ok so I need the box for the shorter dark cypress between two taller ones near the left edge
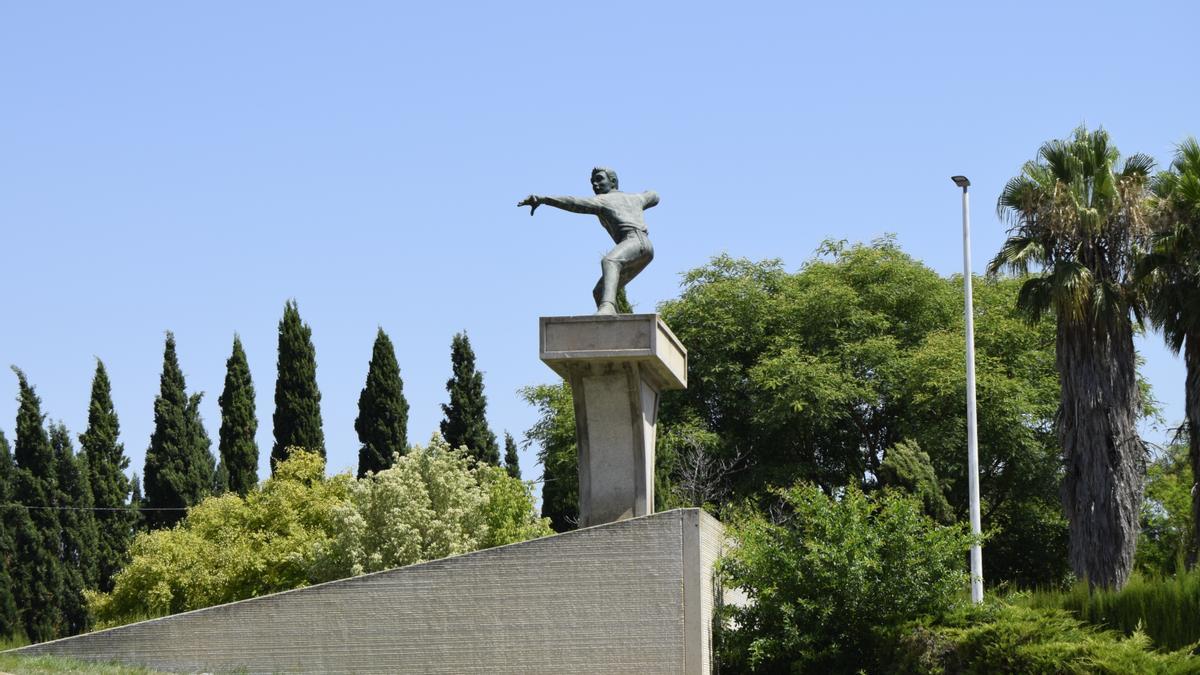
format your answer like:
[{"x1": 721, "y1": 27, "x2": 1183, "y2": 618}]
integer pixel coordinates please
[{"x1": 50, "y1": 422, "x2": 97, "y2": 635}]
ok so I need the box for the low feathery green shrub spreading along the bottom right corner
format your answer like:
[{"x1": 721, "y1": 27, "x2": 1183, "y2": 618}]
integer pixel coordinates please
[{"x1": 888, "y1": 602, "x2": 1200, "y2": 675}]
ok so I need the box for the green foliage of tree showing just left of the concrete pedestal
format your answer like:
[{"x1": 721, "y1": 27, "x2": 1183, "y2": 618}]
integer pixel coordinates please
[{"x1": 521, "y1": 381, "x2": 580, "y2": 532}]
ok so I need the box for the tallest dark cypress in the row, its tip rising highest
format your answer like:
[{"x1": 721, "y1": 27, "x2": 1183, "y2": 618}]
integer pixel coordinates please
[{"x1": 271, "y1": 300, "x2": 325, "y2": 472}]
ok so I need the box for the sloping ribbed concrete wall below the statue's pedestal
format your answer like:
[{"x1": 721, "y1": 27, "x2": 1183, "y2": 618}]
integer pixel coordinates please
[{"x1": 9, "y1": 509, "x2": 724, "y2": 674}]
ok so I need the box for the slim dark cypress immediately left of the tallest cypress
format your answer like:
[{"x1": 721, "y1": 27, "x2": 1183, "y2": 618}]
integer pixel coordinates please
[{"x1": 217, "y1": 335, "x2": 258, "y2": 496}]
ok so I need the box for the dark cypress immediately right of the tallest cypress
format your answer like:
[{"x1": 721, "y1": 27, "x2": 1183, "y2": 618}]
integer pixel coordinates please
[{"x1": 354, "y1": 328, "x2": 408, "y2": 478}]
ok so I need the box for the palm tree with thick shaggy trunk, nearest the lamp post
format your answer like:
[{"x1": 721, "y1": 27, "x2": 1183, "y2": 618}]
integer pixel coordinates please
[{"x1": 989, "y1": 127, "x2": 1154, "y2": 587}]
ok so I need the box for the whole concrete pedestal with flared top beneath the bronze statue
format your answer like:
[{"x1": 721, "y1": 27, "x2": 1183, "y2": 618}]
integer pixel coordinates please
[{"x1": 539, "y1": 313, "x2": 688, "y2": 527}]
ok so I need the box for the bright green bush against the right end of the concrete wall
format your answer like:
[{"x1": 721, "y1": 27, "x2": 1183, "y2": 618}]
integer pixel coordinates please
[{"x1": 720, "y1": 484, "x2": 971, "y2": 673}]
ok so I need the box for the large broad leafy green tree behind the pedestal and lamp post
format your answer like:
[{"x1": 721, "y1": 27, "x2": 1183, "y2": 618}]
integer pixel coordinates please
[{"x1": 648, "y1": 238, "x2": 1067, "y2": 585}]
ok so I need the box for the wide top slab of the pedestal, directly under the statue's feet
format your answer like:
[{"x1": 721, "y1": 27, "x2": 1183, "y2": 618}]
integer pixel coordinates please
[{"x1": 539, "y1": 313, "x2": 688, "y2": 389}]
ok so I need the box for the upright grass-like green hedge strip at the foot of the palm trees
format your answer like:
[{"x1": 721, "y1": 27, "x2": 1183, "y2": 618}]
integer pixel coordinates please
[{"x1": 1013, "y1": 569, "x2": 1200, "y2": 650}]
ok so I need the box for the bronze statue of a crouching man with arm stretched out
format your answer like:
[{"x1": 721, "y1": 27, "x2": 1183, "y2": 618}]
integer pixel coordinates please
[{"x1": 517, "y1": 167, "x2": 659, "y2": 315}]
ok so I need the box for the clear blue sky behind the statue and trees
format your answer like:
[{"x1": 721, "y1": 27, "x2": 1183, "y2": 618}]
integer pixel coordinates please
[{"x1": 0, "y1": 1, "x2": 1200, "y2": 494}]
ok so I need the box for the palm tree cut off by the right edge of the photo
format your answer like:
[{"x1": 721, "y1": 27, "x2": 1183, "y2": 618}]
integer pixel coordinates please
[{"x1": 1138, "y1": 138, "x2": 1200, "y2": 566}]
